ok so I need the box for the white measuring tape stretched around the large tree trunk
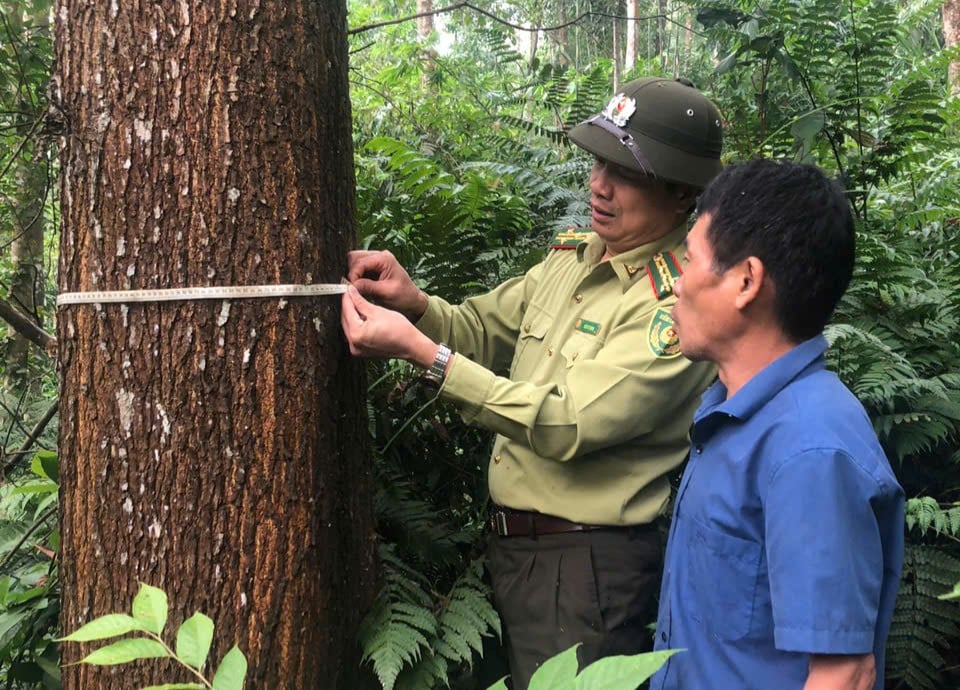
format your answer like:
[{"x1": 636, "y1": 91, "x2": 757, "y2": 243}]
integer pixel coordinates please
[{"x1": 57, "y1": 283, "x2": 348, "y2": 307}]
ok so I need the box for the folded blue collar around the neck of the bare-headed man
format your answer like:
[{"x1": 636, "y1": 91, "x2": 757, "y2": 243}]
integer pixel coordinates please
[{"x1": 693, "y1": 334, "x2": 827, "y2": 424}]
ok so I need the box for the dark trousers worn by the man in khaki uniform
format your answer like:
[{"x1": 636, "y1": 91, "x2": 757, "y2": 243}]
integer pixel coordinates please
[{"x1": 487, "y1": 526, "x2": 661, "y2": 690}]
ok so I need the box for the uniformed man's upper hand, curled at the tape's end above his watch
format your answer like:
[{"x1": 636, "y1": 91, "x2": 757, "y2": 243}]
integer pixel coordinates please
[{"x1": 347, "y1": 250, "x2": 427, "y2": 322}]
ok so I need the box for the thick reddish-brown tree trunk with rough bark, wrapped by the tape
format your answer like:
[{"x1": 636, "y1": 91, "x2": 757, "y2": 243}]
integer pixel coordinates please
[{"x1": 54, "y1": 0, "x2": 374, "y2": 690}]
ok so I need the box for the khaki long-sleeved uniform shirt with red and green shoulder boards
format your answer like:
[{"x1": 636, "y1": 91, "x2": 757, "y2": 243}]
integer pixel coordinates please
[{"x1": 417, "y1": 227, "x2": 715, "y2": 525}]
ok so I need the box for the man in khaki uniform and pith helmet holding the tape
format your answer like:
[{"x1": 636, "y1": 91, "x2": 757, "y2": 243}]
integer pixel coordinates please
[{"x1": 342, "y1": 78, "x2": 721, "y2": 690}]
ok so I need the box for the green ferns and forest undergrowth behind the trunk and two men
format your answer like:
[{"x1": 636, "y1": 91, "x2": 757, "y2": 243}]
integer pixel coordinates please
[{"x1": 0, "y1": 0, "x2": 960, "y2": 690}]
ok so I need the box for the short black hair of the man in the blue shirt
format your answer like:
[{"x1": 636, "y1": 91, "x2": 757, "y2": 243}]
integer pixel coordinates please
[{"x1": 697, "y1": 160, "x2": 856, "y2": 343}]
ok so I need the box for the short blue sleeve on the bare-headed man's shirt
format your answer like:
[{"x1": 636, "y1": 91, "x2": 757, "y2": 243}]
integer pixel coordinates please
[{"x1": 764, "y1": 449, "x2": 884, "y2": 654}]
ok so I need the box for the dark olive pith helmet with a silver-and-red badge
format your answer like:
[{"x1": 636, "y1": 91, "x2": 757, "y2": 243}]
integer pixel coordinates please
[{"x1": 567, "y1": 77, "x2": 723, "y2": 189}]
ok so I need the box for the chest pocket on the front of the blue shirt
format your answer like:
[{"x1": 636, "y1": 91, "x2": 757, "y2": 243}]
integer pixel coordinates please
[{"x1": 687, "y1": 519, "x2": 762, "y2": 640}]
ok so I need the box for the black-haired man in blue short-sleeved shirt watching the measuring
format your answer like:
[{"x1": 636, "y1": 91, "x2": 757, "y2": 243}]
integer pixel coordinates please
[{"x1": 651, "y1": 161, "x2": 904, "y2": 690}]
